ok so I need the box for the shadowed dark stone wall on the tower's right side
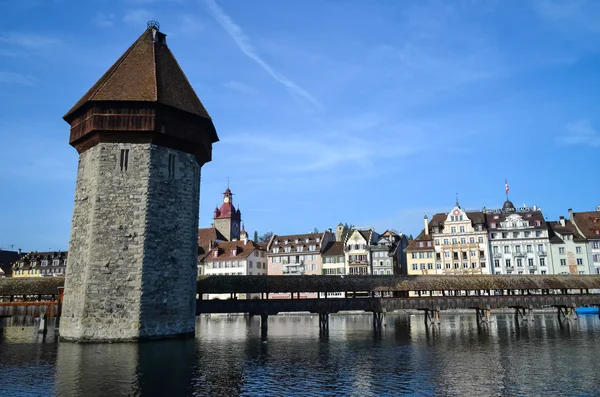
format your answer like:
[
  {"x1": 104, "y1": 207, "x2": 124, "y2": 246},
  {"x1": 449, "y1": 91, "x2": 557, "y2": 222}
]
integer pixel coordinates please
[{"x1": 140, "y1": 146, "x2": 200, "y2": 338}]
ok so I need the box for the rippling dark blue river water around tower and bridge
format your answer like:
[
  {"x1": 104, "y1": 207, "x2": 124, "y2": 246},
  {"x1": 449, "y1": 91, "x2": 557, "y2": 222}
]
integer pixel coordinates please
[{"x1": 0, "y1": 314, "x2": 600, "y2": 397}]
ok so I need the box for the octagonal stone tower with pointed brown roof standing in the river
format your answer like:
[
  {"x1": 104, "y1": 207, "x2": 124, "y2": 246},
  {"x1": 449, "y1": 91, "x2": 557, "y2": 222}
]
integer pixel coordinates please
[{"x1": 60, "y1": 22, "x2": 218, "y2": 341}]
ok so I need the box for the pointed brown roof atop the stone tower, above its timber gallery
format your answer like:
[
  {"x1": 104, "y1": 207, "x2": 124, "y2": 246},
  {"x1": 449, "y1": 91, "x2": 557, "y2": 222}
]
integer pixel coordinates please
[{"x1": 64, "y1": 26, "x2": 210, "y2": 121}]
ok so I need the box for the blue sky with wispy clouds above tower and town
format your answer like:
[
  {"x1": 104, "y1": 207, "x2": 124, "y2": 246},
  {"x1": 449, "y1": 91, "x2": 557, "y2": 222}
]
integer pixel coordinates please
[{"x1": 0, "y1": 0, "x2": 600, "y2": 251}]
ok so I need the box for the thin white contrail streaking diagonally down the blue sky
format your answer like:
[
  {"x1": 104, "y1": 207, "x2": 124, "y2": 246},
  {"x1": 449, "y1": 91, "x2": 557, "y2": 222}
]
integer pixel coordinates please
[{"x1": 204, "y1": 0, "x2": 322, "y2": 108}]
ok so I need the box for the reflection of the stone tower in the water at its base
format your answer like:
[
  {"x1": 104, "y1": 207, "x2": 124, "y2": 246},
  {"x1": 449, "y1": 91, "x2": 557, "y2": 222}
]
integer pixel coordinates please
[{"x1": 54, "y1": 339, "x2": 196, "y2": 396}]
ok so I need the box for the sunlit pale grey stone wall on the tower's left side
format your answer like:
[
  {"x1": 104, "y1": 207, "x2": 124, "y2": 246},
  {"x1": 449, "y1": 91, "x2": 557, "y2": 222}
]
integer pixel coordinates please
[{"x1": 60, "y1": 143, "x2": 151, "y2": 341}]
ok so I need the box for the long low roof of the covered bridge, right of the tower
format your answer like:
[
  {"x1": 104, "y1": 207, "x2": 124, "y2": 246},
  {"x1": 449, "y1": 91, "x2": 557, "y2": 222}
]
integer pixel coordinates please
[{"x1": 198, "y1": 275, "x2": 600, "y2": 293}]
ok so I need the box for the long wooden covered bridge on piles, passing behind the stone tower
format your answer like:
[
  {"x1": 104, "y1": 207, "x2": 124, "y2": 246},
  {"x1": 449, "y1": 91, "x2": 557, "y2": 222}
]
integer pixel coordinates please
[{"x1": 0, "y1": 275, "x2": 600, "y2": 330}]
